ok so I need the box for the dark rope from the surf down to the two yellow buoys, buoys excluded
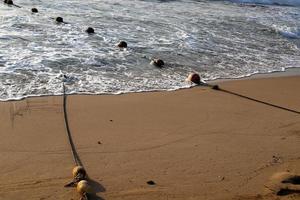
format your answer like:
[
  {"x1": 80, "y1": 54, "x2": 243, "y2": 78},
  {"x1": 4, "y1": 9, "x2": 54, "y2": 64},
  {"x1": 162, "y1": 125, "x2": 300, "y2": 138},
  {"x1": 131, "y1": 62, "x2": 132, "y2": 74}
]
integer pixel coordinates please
[{"x1": 63, "y1": 83, "x2": 82, "y2": 166}]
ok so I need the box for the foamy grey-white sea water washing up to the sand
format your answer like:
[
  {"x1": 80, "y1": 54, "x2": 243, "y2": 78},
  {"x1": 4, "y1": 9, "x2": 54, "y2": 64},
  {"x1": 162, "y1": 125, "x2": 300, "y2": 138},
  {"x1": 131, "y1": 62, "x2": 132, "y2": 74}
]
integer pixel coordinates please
[{"x1": 0, "y1": 0, "x2": 300, "y2": 100}]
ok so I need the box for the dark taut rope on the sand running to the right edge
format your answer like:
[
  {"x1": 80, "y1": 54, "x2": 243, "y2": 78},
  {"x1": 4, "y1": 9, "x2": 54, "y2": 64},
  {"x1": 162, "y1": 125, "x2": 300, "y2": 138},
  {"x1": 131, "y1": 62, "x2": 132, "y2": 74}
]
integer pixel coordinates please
[{"x1": 205, "y1": 84, "x2": 300, "y2": 115}]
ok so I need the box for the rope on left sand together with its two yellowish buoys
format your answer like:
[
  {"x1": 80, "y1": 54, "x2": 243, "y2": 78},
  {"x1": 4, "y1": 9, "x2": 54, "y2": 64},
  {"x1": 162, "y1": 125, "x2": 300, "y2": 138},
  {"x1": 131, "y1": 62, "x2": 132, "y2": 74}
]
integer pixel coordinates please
[{"x1": 63, "y1": 82, "x2": 93, "y2": 200}]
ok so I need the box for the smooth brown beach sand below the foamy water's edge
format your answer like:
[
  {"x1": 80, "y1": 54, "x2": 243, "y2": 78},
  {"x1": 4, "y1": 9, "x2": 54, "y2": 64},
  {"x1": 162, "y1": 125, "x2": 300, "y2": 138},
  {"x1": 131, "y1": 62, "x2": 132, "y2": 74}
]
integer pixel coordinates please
[{"x1": 0, "y1": 76, "x2": 300, "y2": 200}]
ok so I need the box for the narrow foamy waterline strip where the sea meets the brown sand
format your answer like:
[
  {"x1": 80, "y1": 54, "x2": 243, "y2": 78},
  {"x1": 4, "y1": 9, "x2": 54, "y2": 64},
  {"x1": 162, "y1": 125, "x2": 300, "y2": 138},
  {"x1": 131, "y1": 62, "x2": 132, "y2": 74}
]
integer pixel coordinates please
[{"x1": 0, "y1": 67, "x2": 300, "y2": 102}]
